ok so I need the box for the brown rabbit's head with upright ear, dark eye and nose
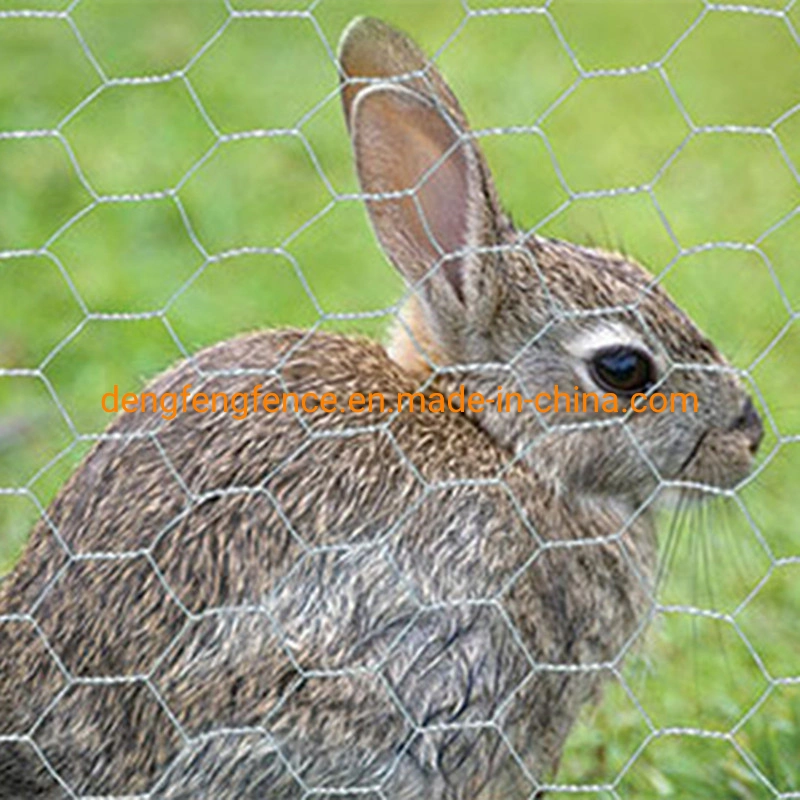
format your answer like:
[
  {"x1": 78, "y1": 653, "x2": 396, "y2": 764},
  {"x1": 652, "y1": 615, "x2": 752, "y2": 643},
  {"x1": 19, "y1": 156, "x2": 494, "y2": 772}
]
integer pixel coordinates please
[{"x1": 340, "y1": 19, "x2": 762, "y2": 502}]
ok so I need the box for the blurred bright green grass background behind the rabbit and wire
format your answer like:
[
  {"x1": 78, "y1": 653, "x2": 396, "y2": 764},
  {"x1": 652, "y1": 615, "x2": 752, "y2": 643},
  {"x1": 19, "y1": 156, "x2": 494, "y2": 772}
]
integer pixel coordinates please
[{"x1": 0, "y1": 0, "x2": 800, "y2": 800}]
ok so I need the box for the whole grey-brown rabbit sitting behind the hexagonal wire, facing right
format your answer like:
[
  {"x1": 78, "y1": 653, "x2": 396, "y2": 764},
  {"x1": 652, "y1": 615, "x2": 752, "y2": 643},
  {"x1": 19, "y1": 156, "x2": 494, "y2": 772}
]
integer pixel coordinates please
[{"x1": 0, "y1": 18, "x2": 763, "y2": 800}]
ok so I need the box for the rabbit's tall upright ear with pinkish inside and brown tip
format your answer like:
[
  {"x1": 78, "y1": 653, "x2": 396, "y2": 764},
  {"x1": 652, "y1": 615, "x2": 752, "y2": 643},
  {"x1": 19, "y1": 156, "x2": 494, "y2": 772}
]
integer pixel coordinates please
[{"x1": 342, "y1": 20, "x2": 501, "y2": 335}]
